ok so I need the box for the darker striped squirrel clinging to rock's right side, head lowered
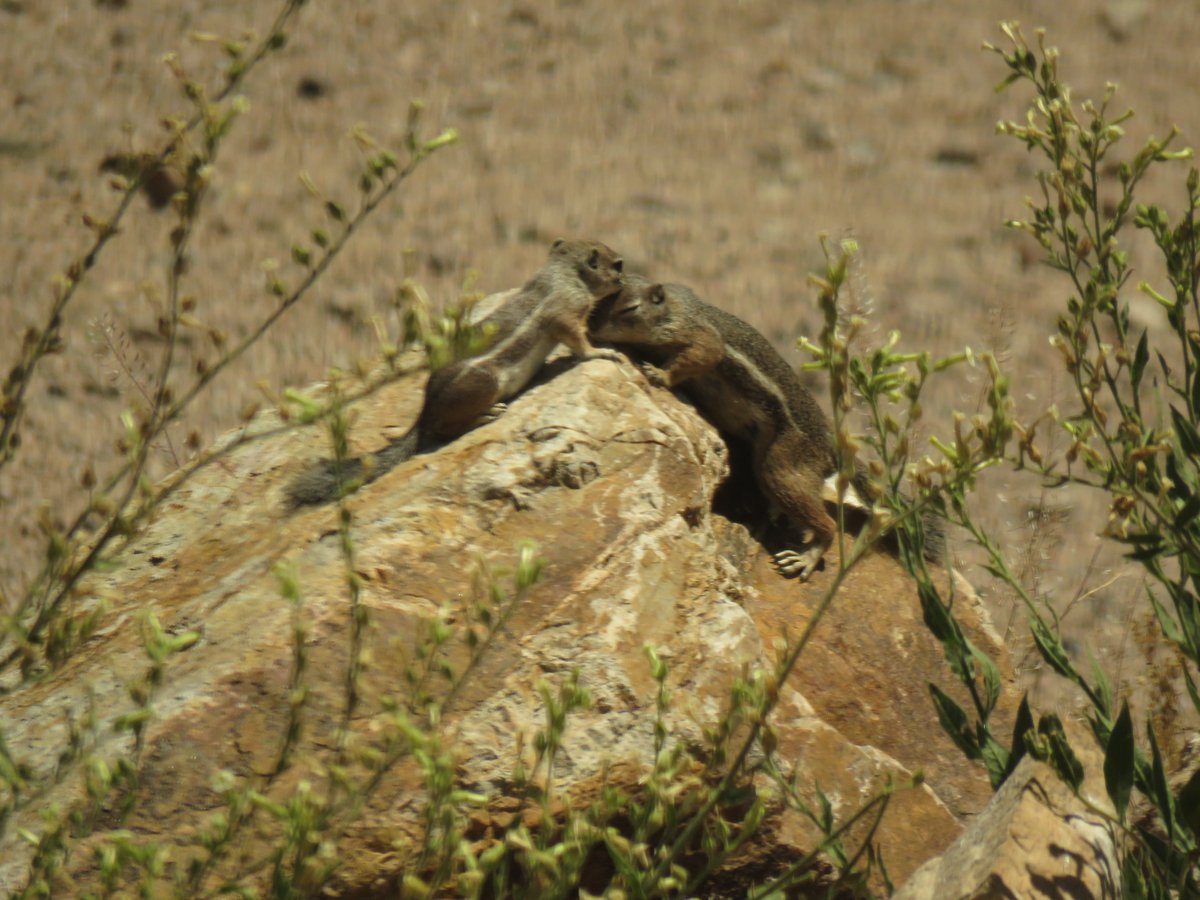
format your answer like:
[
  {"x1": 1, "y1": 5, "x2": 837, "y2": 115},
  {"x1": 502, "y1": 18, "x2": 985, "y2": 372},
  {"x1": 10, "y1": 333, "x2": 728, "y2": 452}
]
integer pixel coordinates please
[{"x1": 590, "y1": 275, "x2": 937, "y2": 581}]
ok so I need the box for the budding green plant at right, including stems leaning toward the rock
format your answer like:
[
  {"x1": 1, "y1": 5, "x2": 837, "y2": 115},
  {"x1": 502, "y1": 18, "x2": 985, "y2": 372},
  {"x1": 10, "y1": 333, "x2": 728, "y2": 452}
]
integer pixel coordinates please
[{"x1": 850, "y1": 23, "x2": 1200, "y2": 898}]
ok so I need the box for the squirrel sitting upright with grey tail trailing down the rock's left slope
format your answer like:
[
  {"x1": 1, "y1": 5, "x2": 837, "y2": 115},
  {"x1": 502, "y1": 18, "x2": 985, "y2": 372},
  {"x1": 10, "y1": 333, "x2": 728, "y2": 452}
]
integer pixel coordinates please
[{"x1": 287, "y1": 239, "x2": 624, "y2": 506}]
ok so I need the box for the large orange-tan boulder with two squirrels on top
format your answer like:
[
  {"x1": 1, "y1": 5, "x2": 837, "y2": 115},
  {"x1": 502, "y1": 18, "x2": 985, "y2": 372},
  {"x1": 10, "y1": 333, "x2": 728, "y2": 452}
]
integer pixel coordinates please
[{"x1": 0, "y1": 350, "x2": 1012, "y2": 896}]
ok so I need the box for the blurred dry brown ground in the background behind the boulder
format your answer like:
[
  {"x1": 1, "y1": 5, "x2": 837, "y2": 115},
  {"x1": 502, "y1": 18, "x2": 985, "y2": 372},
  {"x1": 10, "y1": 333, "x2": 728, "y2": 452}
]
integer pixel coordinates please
[{"x1": 0, "y1": 0, "x2": 1200, "y2": 705}]
